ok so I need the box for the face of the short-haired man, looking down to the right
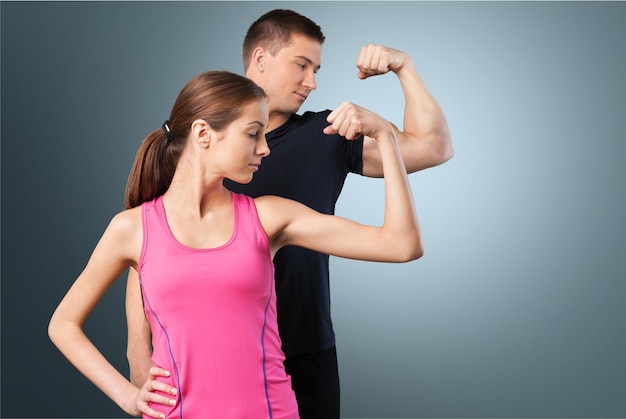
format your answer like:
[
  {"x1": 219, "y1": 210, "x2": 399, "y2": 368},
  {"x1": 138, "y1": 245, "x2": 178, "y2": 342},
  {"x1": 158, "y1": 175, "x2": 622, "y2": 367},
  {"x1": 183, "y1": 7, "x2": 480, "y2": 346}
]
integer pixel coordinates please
[{"x1": 259, "y1": 34, "x2": 322, "y2": 114}]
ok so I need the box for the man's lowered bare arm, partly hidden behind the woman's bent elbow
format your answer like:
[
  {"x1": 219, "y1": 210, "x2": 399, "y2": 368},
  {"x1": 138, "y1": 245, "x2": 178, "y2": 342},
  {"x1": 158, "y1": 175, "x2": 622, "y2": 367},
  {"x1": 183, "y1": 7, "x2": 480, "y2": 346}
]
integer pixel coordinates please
[{"x1": 126, "y1": 268, "x2": 152, "y2": 388}]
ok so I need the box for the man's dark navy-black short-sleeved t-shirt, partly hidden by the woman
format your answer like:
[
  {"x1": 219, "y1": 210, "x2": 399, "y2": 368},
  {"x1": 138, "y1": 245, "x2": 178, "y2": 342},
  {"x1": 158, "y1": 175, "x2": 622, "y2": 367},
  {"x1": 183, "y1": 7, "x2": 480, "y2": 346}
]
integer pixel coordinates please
[{"x1": 224, "y1": 110, "x2": 363, "y2": 355}]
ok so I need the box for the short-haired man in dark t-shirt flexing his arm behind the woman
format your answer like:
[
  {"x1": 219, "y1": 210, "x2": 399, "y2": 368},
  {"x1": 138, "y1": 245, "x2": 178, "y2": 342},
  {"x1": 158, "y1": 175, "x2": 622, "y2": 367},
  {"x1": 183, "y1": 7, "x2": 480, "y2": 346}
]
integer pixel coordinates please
[{"x1": 127, "y1": 10, "x2": 453, "y2": 419}]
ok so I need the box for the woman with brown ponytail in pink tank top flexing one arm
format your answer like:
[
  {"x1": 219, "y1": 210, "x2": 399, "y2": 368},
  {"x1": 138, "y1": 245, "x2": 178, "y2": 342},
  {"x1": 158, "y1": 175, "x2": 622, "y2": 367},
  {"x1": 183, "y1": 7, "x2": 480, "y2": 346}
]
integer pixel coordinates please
[{"x1": 49, "y1": 72, "x2": 422, "y2": 419}]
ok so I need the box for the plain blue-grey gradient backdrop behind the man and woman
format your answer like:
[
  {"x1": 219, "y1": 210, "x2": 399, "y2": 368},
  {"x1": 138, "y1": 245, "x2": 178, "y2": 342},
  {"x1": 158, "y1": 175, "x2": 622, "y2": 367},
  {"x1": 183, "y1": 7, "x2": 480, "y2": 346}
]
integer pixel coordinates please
[{"x1": 1, "y1": 2, "x2": 626, "y2": 418}]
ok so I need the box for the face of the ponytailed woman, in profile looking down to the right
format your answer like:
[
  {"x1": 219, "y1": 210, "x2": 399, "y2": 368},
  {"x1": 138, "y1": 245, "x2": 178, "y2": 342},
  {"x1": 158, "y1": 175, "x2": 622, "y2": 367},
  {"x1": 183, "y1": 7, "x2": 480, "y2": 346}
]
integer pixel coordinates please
[{"x1": 214, "y1": 100, "x2": 270, "y2": 183}]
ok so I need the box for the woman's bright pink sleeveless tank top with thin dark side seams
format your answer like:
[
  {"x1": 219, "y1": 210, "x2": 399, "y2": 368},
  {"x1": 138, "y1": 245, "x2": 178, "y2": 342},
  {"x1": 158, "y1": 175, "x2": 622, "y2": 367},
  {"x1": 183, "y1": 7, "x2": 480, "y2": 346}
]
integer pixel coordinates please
[{"x1": 139, "y1": 193, "x2": 298, "y2": 419}]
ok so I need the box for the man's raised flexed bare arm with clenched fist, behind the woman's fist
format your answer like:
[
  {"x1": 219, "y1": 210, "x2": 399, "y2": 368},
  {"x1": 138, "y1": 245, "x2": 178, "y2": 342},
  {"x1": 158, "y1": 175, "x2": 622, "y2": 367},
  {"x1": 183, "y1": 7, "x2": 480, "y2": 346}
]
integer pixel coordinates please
[{"x1": 357, "y1": 44, "x2": 454, "y2": 177}]
